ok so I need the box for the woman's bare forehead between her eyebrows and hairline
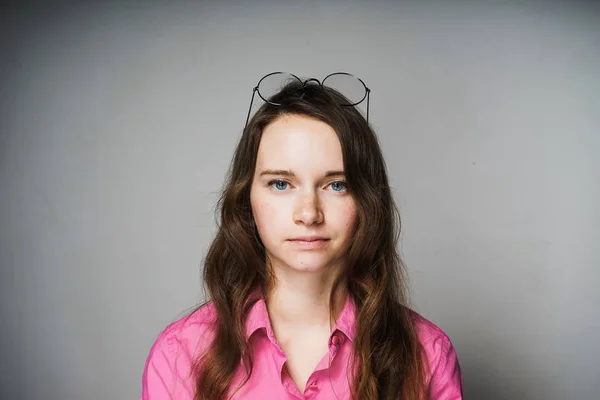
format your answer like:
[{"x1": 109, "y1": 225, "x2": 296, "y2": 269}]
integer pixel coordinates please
[{"x1": 256, "y1": 115, "x2": 344, "y2": 173}]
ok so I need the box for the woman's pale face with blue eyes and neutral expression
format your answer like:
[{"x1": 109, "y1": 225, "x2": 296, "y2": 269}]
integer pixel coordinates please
[{"x1": 250, "y1": 115, "x2": 356, "y2": 272}]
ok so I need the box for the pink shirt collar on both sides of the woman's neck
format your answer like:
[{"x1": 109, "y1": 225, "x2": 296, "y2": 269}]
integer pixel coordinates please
[{"x1": 246, "y1": 295, "x2": 356, "y2": 341}]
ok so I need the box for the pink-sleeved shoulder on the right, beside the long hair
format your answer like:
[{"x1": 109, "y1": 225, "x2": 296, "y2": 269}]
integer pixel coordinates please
[{"x1": 410, "y1": 311, "x2": 463, "y2": 399}]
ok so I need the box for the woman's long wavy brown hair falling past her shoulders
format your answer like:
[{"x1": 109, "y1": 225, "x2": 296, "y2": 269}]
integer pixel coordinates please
[{"x1": 193, "y1": 83, "x2": 426, "y2": 400}]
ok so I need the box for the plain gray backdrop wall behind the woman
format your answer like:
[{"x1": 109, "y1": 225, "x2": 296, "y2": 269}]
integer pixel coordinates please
[{"x1": 0, "y1": 1, "x2": 600, "y2": 400}]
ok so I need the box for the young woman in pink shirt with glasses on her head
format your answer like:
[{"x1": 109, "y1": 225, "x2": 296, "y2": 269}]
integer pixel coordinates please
[{"x1": 141, "y1": 74, "x2": 462, "y2": 400}]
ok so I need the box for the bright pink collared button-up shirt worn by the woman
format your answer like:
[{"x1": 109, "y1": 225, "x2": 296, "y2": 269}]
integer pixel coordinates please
[{"x1": 140, "y1": 297, "x2": 462, "y2": 400}]
